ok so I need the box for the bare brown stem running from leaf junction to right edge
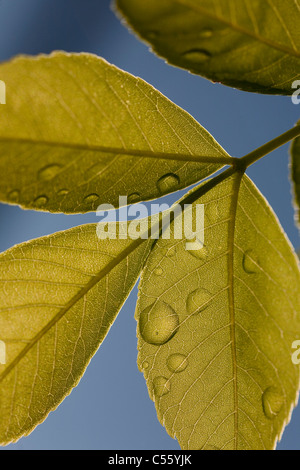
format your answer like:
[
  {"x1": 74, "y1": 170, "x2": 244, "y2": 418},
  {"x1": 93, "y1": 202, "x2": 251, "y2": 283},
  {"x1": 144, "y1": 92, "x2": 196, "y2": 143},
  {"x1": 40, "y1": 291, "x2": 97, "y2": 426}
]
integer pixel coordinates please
[{"x1": 238, "y1": 124, "x2": 300, "y2": 169}]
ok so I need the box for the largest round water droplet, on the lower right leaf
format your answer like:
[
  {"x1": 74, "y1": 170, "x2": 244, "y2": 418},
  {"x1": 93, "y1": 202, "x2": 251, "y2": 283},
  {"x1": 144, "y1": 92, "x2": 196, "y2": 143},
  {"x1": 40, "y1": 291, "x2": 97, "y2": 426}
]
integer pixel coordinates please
[{"x1": 139, "y1": 301, "x2": 179, "y2": 345}]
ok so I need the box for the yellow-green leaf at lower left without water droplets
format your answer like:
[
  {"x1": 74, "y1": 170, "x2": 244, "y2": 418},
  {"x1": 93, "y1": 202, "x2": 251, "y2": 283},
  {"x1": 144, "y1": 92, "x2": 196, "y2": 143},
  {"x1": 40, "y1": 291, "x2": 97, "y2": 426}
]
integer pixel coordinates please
[{"x1": 0, "y1": 224, "x2": 150, "y2": 445}]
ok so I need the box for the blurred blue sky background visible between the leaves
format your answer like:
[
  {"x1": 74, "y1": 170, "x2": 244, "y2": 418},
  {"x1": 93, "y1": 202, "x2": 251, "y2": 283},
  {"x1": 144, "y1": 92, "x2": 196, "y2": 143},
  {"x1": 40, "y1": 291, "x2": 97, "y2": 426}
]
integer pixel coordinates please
[{"x1": 0, "y1": 0, "x2": 300, "y2": 450}]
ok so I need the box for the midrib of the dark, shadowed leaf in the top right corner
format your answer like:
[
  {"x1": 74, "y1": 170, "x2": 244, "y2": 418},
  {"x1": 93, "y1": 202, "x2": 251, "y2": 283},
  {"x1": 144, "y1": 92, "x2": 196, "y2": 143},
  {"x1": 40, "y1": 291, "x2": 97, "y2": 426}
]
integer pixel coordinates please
[{"x1": 174, "y1": 0, "x2": 300, "y2": 58}]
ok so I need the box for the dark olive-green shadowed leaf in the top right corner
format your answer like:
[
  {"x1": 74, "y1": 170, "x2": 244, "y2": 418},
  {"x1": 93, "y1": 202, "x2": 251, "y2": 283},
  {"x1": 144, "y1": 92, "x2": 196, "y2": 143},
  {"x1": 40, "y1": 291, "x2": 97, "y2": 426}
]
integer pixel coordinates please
[{"x1": 117, "y1": 0, "x2": 300, "y2": 95}]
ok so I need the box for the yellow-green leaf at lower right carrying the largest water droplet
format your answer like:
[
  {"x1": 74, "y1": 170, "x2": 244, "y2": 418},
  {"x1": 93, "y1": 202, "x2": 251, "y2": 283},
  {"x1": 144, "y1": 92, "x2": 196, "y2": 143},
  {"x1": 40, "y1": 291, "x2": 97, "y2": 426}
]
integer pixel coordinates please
[{"x1": 136, "y1": 174, "x2": 300, "y2": 450}]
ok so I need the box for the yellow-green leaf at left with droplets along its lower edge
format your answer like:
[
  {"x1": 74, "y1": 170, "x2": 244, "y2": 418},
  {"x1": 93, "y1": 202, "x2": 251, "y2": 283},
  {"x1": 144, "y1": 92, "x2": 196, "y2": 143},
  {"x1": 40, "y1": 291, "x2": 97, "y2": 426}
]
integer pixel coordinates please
[{"x1": 0, "y1": 53, "x2": 230, "y2": 213}]
